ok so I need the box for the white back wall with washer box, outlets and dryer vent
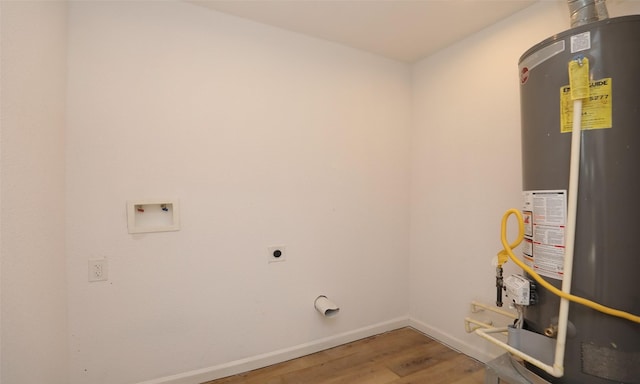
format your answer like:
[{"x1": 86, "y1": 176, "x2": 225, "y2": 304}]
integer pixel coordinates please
[{"x1": 66, "y1": 2, "x2": 411, "y2": 384}]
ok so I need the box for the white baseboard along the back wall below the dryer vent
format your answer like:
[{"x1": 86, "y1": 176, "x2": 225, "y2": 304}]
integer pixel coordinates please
[{"x1": 138, "y1": 317, "x2": 410, "y2": 384}]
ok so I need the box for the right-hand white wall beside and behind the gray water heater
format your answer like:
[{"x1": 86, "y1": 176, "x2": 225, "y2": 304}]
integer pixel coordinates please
[{"x1": 410, "y1": 1, "x2": 640, "y2": 360}]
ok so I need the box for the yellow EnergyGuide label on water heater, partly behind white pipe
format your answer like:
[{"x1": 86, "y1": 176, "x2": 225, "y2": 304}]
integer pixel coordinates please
[{"x1": 560, "y1": 77, "x2": 612, "y2": 133}]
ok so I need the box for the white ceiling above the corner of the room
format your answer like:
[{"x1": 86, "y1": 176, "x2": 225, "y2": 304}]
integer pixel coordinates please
[{"x1": 188, "y1": 0, "x2": 537, "y2": 62}]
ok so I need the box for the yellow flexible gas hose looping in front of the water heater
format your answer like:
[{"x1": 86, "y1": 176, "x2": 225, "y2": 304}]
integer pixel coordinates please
[{"x1": 498, "y1": 208, "x2": 640, "y2": 323}]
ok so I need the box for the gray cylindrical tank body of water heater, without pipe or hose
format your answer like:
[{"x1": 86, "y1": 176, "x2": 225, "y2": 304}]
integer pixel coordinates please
[{"x1": 519, "y1": 15, "x2": 640, "y2": 384}]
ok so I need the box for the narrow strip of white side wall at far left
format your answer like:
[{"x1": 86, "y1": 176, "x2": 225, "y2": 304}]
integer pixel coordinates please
[{"x1": 0, "y1": 1, "x2": 68, "y2": 384}]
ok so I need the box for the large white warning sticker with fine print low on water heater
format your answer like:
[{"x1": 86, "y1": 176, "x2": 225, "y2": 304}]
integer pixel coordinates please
[{"x1": 522, "y1": 190, "x2": 567, "y2": 280}]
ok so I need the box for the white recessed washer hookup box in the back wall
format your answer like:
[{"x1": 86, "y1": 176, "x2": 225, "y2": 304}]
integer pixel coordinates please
[{"x1": 127, "y1": 199, "x2": 180, "y2": 233}]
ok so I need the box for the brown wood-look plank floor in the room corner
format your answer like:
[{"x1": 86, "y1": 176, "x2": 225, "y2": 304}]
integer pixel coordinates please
[{"x1": 203, "y1": 328, "x2": 484, "y2": 384}]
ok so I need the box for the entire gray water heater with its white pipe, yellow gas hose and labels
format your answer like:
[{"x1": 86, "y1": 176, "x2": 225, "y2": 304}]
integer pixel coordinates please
[{"x1": 471, "y1": 0, "x2": 640, "y2": 384}]
